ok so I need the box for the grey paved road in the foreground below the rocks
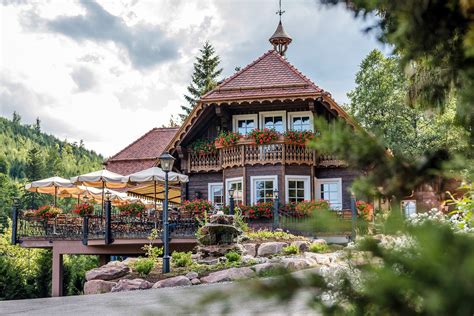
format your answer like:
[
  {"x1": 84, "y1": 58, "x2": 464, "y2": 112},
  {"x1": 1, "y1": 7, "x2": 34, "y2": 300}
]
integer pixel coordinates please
[{"x1": 0, "y1": 283, "x2": 314, "y2": 316}]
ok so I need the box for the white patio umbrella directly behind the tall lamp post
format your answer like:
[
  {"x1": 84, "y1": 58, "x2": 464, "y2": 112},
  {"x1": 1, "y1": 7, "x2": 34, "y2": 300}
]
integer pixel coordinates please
[{"x1": 122, "y1": 167, "x2": 189, "y2": 223}]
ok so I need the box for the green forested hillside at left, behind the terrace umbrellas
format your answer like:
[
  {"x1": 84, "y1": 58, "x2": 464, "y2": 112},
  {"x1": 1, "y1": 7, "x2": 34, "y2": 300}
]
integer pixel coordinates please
[{"x1": 0, "y1": 113, "x2": 103, "y2": 222}]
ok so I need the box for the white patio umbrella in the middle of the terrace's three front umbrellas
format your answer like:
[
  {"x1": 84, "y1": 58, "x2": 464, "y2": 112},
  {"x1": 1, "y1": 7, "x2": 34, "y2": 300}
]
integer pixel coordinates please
[{"x1": 71, "y1": 169, "x2": 127, "y2": 216}]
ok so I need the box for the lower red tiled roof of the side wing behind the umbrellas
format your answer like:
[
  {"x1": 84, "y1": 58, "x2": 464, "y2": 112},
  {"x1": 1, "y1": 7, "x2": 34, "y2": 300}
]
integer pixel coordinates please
[{"x1": 105, "y1": 127, "x2": 178, "y2": 175}]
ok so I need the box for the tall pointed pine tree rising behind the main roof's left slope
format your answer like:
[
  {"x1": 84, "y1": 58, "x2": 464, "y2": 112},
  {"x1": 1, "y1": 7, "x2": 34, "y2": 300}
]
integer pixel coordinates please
[{"x1": 179, "y1": 42, "x2": 222, "y2": 119}]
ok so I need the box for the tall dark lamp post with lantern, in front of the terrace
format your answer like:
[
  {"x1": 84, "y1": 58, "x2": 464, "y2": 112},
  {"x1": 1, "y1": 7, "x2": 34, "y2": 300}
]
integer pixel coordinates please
[{"x1": 158, "y1": 152, "x2": 175, "y2": 273}]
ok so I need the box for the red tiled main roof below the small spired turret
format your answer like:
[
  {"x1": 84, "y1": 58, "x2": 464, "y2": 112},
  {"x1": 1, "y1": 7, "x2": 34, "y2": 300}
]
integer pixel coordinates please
[{"x1": 201, "y1": 49, "x2": 325, "y2": 102}]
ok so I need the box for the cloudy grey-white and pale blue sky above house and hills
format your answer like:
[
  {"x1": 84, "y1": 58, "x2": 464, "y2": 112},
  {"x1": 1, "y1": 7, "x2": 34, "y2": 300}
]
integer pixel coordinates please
[{"x1": 0, "y1": 0, "x2": 384, "y2": 157}]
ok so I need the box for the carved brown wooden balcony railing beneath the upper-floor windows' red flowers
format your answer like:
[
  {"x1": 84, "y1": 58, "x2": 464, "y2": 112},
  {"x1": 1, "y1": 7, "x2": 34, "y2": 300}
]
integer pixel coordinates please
[{"x1": 188, "y1": 138, "x2": 345, "y2": 172}]
